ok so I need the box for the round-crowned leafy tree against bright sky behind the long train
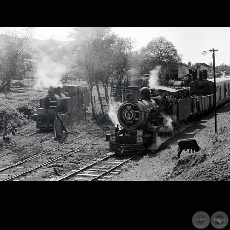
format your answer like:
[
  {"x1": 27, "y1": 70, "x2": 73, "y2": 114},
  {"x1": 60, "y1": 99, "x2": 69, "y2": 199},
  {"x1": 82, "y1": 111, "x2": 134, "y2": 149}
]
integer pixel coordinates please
[{"x1": 138, "y1": 37, "x2": 181, "y2": 73}]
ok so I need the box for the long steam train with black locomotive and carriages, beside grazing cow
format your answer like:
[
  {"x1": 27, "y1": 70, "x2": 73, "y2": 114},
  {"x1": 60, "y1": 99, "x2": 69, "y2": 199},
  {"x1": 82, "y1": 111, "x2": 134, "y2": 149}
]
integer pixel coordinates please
[{"x1": 109, "y1": 77, "x2": 230, "y2": 155}]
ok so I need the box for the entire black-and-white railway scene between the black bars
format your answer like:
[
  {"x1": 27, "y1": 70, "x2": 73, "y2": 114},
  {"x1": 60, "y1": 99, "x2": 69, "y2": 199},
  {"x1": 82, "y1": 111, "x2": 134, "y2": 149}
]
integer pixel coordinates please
[{"x1": 0, "y1": 27, "x2": 230, "y2": 181}]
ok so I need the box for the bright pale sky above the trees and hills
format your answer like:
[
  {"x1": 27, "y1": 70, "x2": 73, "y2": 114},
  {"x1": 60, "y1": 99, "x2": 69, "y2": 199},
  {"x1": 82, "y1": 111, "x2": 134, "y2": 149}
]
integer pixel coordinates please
[{"x1": 0, "y1": 27, "x2": 230, "y2": 65}]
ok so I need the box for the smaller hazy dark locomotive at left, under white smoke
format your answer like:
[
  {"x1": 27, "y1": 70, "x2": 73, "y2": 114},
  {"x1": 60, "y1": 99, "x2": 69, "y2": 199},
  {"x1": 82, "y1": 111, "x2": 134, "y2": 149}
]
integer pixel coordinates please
[{"x1": 32, "y1": 85, "x2": 90, "y2": 135}]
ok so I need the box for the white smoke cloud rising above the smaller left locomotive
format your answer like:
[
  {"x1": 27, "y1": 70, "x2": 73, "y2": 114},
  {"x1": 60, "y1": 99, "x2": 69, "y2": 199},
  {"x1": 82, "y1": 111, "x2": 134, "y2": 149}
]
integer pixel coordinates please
[{"x1": 34, "y1": 56, "x2": 66, "y2": 90}]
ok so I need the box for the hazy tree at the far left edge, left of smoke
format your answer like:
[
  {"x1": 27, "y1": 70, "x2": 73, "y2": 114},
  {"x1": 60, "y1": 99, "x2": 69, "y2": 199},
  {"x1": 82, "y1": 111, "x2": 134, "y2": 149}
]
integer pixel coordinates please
[{"x1": 0, "y1": 28, "x2": 33, "y2": 92}]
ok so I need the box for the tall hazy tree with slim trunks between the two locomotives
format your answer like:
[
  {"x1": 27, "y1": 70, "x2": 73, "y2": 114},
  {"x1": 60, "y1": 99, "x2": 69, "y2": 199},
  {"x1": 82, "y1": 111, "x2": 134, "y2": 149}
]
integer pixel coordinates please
[{"x1": 69, "y1": 27, "x2": 131, "y2": 118}]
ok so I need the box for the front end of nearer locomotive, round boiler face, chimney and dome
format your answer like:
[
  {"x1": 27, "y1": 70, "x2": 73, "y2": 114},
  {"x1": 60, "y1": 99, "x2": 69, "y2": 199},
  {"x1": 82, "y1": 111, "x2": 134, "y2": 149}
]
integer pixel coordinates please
[{"x1": 109, "y1": 86, "x2": 171, "y2": 155}]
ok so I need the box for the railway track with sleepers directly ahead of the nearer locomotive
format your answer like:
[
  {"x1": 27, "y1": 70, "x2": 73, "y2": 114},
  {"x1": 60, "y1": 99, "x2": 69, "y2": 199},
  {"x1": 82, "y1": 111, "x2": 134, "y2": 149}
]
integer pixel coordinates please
[{"x1": 47, "y1": 154, "x2": 136, "y2": 181}]
